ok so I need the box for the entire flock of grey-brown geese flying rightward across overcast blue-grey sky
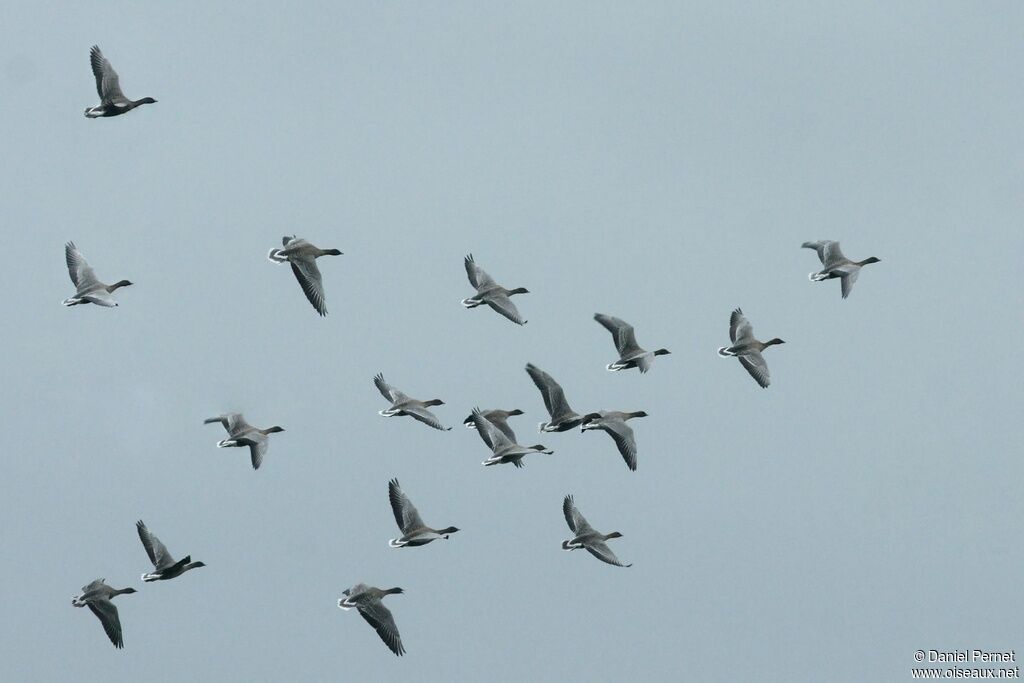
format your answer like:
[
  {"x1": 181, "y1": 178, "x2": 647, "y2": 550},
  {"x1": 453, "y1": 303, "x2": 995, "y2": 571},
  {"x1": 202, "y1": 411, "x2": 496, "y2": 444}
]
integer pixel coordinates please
[{"x1": 70, "y1": 46, "x2": 880, "y2": 655}]
